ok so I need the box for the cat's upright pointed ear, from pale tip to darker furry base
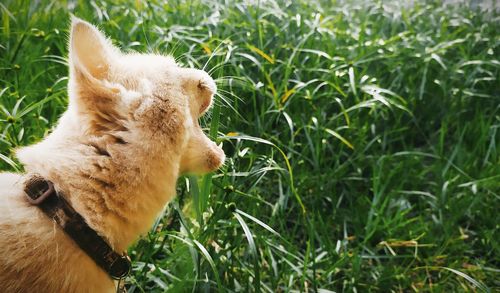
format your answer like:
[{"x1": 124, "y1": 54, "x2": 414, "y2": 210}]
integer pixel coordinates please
[{"x1": 68, "y1": 17, "x2": 125, "y2": 133}]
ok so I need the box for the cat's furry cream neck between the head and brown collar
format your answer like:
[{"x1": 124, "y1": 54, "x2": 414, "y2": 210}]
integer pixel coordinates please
[{"x1": 18, "y1": 114, "x2": 179, "y2": 251}]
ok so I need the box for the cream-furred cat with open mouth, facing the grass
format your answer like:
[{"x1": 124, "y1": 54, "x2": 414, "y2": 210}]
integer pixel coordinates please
[{"x1": 0, "y1": 16, "x2": 225, "y2": 292}]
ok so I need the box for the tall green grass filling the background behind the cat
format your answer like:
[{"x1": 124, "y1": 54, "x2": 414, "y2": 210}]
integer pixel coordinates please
[{"x1": 0, "y1": 0, "x2": 500, "y2": 292}]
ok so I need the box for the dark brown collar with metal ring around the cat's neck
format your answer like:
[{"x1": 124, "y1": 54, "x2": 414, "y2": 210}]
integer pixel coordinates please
[{"x1": 24, "y1": 175, "x2": 131, "y2": 280}]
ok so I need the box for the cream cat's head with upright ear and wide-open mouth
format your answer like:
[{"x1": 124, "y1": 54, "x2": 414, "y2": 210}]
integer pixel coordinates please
[{"x1": 69, "y1": 17, "x2": 225, "y2": 174}]
